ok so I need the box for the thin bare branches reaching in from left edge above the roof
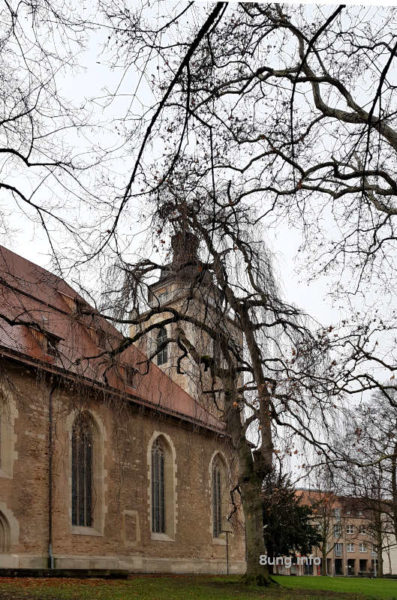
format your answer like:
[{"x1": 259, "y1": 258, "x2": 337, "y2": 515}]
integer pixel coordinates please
[{"x1": 0, "y1": 0, "x2": 109, "y2": 267}]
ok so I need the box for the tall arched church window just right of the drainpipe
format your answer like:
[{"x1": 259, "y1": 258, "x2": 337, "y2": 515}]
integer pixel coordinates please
[{"x1": 72, "y1": 414, "x2": 93, "y2": 527}]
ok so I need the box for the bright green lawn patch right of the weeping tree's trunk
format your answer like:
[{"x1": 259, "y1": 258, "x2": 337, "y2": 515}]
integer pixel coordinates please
[{"x1": 275, "y1": 577, "x2": 397, "y2": 600}]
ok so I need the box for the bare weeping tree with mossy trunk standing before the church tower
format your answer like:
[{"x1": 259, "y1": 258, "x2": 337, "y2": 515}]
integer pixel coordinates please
[{"x1": 97, "y1": 195, "x2": 338, "y2": 583}]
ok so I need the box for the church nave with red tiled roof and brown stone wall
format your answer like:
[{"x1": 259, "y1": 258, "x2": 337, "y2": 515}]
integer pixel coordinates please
[{"x1": 0, "y1": 247, "x2": 245, "y2": 574}]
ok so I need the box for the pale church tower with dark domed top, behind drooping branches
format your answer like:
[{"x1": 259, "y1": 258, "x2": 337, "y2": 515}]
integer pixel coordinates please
[{"x1": 131, "y1": 229, "x2": 242, "y2": 418}]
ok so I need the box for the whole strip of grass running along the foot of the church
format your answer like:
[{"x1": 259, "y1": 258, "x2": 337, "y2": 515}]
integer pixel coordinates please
[{"x1": 0, "y1": 576, "x2": 397, "y2": 600}]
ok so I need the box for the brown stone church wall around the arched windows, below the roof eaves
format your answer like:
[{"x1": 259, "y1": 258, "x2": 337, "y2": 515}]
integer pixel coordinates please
[{"x1": 0, "y1": 361, "x2": 245, "y2": 573}]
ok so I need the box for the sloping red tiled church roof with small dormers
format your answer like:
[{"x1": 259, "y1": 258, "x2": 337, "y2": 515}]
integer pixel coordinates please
[{"x1": 0, "y1": 246, "x2": 224, "y2": 432}]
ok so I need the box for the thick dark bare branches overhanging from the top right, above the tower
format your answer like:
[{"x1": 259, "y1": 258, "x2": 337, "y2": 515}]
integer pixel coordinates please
[{"x1": 96, "y1": 0, "x2": 396, "y2": 394}]
